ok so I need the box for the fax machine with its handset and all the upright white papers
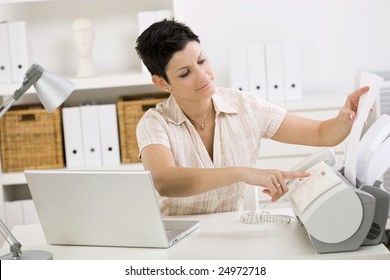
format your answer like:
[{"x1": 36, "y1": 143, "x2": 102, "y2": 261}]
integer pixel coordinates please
[{"x1": 288, "y1": 73, "x2": 390, "y2": 253}]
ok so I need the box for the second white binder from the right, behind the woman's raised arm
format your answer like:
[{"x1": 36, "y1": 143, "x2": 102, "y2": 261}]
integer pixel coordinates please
[{"x1": 265, "y1": 43, "x2": 285, "y2": 102}]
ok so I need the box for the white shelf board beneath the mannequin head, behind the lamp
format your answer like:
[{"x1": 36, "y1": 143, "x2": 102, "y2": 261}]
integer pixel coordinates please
[{"x1": 0, "y1": 72, "x2": 153, "y2": 95}]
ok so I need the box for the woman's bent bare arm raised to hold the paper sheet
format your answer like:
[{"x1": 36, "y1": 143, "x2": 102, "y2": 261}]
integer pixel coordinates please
[{"x1": 272, "y1": 87, "x2": 368, "y2": 146}]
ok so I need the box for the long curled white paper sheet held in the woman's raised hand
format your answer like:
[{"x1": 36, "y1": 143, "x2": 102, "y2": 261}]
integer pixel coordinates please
[{"x1": 344, "y1": 73, "x2": 383, "y2": 186}]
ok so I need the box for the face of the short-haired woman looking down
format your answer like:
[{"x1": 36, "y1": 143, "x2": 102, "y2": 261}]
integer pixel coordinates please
[{"x1": 166, "y1": 41, "x2": 215, "y2": 100}]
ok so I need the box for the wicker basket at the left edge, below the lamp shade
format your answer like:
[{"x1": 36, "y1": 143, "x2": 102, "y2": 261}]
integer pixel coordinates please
[{"x1": 0, "y1": 106, "x2": 64, "y2": 172}]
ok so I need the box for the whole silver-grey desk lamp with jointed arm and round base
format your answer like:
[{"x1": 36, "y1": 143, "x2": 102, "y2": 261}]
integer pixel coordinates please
[{"x1": 0, "y1": 64, "x2": 75, "y2": 260}]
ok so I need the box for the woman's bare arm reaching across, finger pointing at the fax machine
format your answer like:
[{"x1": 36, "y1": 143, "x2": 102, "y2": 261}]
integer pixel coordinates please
[{"x1": 142, "y1": 145, "x2": 309, "y2": 201}]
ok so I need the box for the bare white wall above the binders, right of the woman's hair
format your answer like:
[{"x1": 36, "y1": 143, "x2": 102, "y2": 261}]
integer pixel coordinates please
[{"x1": 178, "y1": 0, "x2": 390, "y2": 94}]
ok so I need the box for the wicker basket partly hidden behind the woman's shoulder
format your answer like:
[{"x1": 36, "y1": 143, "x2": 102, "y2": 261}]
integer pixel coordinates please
[{"x1": 117, "y1": 94, "x2": 168, "y2": 163}]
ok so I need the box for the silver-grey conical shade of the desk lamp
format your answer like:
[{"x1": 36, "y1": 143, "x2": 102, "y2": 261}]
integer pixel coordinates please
[{"x1": 34, "y1": 71, "x2": 75, "y2": 112}]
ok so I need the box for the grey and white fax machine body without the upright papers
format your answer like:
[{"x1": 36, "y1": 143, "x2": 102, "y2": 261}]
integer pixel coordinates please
[{"x1": 289, "y1": 149, "x2": 390, "y2": 253}]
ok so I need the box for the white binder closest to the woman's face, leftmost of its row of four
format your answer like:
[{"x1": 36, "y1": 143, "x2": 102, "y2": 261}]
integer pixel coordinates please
[{"x1": 229, "y1": 45, "x2": 249, "y2": 91}]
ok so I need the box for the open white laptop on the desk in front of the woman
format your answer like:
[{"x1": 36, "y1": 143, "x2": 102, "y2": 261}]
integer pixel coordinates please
[{"x1": 24, "y1": 170, "x2": 199, "y2": 248}]
